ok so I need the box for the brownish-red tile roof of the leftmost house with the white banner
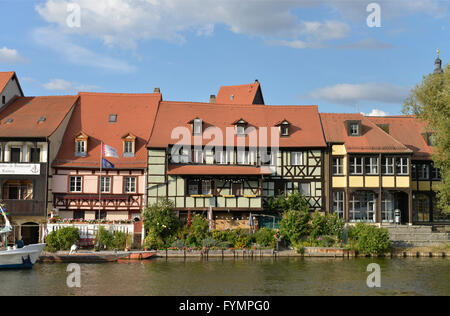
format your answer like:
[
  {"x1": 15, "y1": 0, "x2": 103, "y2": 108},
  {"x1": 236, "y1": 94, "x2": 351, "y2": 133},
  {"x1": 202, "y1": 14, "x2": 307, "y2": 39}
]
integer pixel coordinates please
[{"x1": 0, "y1": 96, "x2": 78, "y2": 137}]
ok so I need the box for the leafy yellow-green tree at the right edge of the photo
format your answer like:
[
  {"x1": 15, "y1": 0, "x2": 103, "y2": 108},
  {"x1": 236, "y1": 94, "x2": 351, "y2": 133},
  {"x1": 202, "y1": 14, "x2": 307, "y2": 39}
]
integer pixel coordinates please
[{"x1": 403, "y1": 65, "x2": 450, "y2": 214}]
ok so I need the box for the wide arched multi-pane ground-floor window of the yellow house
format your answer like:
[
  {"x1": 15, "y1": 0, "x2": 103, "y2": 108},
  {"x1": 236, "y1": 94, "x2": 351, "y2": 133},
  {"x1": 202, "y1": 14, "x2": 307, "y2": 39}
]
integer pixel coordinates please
[{"x1": 350, "y1": 191, "x2": 377, "y2": 222}]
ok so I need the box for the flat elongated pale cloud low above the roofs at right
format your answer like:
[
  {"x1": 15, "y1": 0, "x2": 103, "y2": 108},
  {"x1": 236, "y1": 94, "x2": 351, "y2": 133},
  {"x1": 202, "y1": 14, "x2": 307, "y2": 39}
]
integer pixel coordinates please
[{"x1": 308, "y1": 83, "x2": 410, "y2": 105}]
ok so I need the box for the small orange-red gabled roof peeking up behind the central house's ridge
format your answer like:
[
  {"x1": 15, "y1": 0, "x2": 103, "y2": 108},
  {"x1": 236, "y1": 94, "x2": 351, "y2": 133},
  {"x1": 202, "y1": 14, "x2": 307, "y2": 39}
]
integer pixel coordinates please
[{"x1": 216, "y1": 80, "x2": 264, "y2": 104}]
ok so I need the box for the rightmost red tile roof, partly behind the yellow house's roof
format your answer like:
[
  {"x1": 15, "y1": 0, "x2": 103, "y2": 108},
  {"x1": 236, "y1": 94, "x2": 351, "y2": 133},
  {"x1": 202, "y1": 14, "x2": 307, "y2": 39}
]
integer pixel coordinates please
[{"x1": 367, "y1": 115, "x2": 432, "y2": 160}]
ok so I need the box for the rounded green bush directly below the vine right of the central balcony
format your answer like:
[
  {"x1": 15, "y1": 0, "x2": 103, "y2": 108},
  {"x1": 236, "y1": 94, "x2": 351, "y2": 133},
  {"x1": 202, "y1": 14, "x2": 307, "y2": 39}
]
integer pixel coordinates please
[{"x1": 280, "y1": 210, "x2": 310, "y2": 245}]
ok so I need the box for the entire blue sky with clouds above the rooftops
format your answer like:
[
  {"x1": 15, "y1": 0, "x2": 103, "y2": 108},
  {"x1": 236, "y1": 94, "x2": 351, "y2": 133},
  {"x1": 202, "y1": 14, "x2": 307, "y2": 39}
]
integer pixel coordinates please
[{"x1": 0, "y1": 0, "x2": 450, "y2": 115}]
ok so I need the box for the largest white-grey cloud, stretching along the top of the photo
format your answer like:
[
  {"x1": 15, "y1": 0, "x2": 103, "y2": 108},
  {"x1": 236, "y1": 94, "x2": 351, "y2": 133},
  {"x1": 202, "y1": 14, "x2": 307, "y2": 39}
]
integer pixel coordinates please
[{"x1": 36, "y1": 0, "x2": 350, "y2": 48}]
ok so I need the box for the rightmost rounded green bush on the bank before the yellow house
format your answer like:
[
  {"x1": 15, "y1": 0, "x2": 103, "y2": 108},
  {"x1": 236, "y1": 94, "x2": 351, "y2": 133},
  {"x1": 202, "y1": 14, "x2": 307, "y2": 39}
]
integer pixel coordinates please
[{"x1": 349, "y1": 223, "x2": 391, "y2": 254}]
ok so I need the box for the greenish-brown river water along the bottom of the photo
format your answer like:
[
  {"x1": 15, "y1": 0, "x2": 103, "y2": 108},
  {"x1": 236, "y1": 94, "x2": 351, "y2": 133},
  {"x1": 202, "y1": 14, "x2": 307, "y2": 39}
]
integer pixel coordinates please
[{"x1": 0, "y1": 258, "x2": 450, "y2": 296}]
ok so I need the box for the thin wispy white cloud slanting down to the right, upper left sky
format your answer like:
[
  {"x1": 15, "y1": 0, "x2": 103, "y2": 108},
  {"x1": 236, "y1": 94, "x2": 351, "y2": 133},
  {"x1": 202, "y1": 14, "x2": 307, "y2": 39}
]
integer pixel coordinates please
[{"x1": 33, "y1": 27, "x2": 135, "y2": 72}]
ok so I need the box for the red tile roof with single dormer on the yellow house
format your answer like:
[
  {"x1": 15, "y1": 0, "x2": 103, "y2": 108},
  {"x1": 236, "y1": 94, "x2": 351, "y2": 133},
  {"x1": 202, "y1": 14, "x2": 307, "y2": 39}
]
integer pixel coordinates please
[{"x1": 320, "y1": 113, "x2": 412, "y2": 153}]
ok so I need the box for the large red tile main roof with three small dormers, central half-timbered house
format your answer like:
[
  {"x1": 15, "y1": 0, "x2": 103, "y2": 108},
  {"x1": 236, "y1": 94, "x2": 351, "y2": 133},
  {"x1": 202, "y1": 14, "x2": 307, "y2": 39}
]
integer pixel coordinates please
[{"x1": 148, "y1": 101, "x2": 326, "y2": 148}]
